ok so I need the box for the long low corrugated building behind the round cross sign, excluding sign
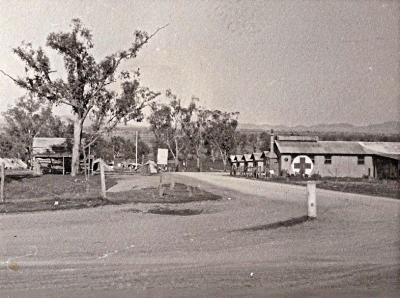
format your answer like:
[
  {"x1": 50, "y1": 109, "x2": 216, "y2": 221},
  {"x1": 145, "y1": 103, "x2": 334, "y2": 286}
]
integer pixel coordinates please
[{"x1": 271, "y1": 136, "x2": 400, "y2": 178}]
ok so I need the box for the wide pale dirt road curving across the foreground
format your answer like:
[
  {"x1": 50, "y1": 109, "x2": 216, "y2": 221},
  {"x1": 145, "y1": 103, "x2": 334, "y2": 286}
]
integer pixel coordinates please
[{"x1": 0, "y1": 173, "x2": 400, "y2": 297}]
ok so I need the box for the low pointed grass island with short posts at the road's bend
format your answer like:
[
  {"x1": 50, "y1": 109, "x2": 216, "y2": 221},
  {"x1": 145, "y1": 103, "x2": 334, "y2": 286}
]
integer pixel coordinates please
[{"x1": 108, "y1": 183, "x2": 222, "y2": 204}]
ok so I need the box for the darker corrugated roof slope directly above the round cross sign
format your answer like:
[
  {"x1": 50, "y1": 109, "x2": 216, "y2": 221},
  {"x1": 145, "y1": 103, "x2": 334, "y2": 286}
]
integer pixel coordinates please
[{"x1": 275, "y1": 141, "x2": 371, "y2": 155}]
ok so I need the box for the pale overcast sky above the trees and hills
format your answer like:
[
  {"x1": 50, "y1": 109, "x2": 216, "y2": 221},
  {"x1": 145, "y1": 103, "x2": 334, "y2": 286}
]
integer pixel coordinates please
[{"x1": 0, "y1": 0, "x2": 400, "y2": 125}]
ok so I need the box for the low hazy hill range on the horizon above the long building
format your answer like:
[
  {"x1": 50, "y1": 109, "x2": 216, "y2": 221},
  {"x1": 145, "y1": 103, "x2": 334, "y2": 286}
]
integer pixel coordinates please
[{"x1": 239, "y1": 121, "x2": 400, "y2": 134}]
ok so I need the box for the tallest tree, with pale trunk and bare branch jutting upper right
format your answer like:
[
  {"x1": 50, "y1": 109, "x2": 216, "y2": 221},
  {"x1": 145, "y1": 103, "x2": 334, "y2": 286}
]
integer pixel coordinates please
[{"x1": 2, "y1": 19, "x2": 162, "y2": 176}]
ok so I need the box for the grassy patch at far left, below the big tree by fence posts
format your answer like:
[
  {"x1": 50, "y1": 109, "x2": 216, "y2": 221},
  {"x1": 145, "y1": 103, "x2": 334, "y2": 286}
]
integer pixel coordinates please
[{"x1": 0, "y1": 175, "x2": 116, "y2": 213}]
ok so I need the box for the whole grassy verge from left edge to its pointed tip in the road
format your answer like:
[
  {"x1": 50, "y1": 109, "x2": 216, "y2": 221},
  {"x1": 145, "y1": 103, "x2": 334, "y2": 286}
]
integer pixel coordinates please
[{"x1": 0, "y1": 175, "x2": 221, "y2": 213}]
